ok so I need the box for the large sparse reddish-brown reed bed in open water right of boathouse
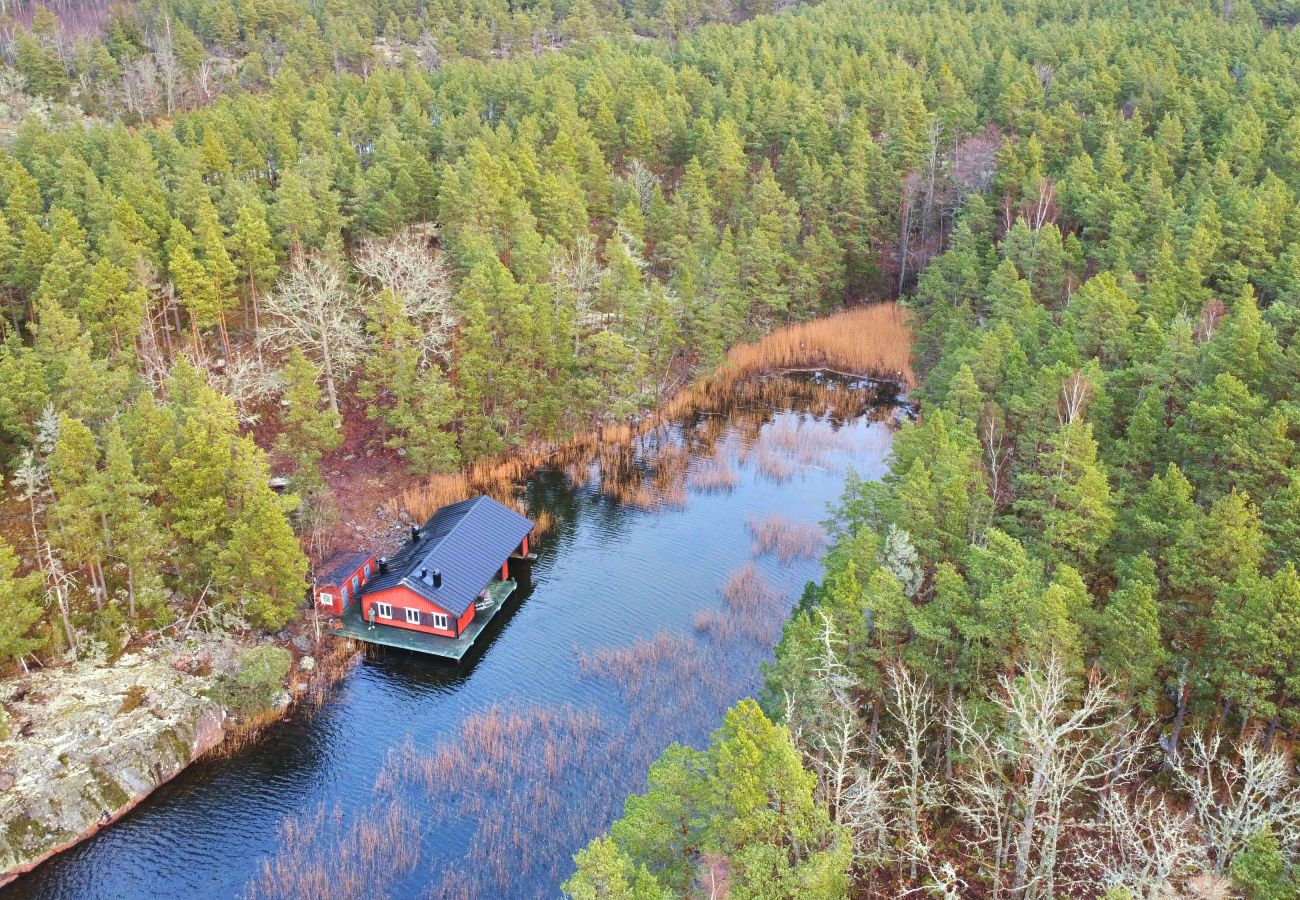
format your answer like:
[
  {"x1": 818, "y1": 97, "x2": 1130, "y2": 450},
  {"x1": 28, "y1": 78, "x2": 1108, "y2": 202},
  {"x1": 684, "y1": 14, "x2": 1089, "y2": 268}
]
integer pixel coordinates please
[{"x1": 256, "y1": 564, "x2": 787, "y2": 900}]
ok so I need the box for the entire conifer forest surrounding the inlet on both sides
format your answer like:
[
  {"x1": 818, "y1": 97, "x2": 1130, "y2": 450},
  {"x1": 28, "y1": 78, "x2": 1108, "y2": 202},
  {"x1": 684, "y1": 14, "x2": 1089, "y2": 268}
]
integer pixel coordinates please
[{"x1": 0, "y1": 0, "x2": 1300, "y2": 899}]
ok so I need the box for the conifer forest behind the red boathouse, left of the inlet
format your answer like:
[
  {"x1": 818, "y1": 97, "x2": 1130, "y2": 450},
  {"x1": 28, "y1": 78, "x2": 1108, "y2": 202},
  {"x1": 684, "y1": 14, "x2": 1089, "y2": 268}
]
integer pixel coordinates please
[{"x1": 0, "y1": 0, "x2": 915, "y2": 666}]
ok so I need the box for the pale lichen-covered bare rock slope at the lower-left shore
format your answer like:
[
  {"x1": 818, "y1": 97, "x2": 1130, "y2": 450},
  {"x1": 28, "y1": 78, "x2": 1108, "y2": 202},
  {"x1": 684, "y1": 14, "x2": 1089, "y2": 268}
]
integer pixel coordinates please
[{"x1": 0, "y1": 644, "x2": 238, "y2": 884}]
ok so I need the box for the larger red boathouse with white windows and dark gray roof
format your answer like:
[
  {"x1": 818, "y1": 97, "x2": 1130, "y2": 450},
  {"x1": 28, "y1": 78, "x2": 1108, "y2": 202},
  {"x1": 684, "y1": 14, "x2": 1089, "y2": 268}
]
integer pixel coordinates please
[{"x1": 358, "y1": 497, "x2": 533, "y2": 647}]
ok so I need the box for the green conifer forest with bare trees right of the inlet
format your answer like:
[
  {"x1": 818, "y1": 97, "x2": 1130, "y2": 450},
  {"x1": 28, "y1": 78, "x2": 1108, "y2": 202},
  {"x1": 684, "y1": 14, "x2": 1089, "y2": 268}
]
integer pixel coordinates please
[{"x1": 566, "y1": 0, "x2": 1300, "y2": 899}]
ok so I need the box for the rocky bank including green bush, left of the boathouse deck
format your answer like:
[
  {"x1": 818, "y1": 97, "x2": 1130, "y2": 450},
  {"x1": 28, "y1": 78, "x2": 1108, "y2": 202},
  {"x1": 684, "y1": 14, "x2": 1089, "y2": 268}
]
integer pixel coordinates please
[{"x1": 0, "y1": 628, "x2": 355, "y2": 884}]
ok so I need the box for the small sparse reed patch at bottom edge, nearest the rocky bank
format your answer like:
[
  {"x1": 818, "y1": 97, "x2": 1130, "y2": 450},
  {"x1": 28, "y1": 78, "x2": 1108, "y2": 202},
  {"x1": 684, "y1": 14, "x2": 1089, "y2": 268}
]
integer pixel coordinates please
[{"x1": 246, "y1": 797, "x2": 420, "y2": 900}]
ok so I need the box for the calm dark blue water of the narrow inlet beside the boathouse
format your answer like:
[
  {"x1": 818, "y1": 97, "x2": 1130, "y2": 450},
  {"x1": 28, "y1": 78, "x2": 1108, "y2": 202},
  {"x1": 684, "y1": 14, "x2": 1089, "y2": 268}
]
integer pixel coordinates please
[{"x1": 10, "y1": 378, "x2": 892, "y2": 900}]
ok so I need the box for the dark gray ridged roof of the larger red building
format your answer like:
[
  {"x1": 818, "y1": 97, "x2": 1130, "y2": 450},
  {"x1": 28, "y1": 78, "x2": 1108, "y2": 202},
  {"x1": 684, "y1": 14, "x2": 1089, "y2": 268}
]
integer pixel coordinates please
[{"x1": 361, "y1": 497, "x2": 533, "y2": 618}]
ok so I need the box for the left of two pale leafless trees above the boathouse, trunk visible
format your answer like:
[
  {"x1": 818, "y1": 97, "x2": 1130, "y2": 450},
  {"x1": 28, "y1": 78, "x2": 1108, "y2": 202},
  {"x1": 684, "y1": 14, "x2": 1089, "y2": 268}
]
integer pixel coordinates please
[{"x1": 259, "y1": 255, "x2": 365, "y2": 414}]
